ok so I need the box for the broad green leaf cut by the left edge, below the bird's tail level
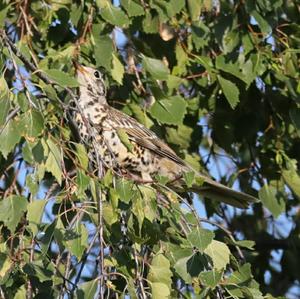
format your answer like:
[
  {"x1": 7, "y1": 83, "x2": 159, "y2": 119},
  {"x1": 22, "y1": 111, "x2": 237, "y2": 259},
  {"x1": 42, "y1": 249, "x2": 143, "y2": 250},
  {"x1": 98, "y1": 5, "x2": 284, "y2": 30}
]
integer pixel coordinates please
[{"x1": 0, "y1": 195, "x2": 28, "y2": 233}]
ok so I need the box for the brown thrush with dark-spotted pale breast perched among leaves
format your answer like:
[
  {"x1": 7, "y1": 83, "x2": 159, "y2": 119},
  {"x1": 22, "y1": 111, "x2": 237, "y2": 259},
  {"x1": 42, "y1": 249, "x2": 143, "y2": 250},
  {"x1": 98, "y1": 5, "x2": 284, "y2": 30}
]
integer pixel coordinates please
[{"x1": 73, "y1": 61, "x2": 257, "y2": 208}]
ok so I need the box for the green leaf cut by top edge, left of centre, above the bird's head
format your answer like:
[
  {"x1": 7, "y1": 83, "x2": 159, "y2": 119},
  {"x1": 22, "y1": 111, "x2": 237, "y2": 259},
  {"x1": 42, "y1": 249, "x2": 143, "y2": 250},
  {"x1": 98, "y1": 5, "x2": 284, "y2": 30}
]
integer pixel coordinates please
[{"x1": 100, "y1": 1, "x2": 130, "y2": 27}]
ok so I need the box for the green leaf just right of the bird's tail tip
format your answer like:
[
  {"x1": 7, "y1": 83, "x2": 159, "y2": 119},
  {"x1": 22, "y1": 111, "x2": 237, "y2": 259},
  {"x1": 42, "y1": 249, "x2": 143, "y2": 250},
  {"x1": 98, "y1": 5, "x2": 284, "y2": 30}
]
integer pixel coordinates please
[{"x1": 258, "y1": 184, "x2": 285, "y2": 218}]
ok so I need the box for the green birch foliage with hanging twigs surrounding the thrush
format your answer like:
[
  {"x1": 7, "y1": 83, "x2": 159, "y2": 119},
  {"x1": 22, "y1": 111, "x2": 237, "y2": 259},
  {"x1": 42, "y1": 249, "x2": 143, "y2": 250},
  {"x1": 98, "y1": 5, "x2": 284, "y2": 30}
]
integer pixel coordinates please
[{"x1": 0, "y1": 0, "x2": 300, "y2": 298}]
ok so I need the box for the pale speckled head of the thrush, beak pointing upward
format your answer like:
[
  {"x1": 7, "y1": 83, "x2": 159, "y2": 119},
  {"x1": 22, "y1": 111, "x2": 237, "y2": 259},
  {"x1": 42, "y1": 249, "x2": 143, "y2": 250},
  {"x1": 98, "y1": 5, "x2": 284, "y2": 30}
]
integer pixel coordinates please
[{"x1": 73, "y1": 61, "x2": 106, "y2": 102}]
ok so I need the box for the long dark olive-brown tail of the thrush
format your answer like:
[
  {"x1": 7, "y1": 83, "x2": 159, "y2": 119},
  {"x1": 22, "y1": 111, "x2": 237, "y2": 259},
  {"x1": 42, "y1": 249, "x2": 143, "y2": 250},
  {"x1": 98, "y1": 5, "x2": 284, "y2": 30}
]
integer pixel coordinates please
[{"x1": 191, "y1": 174, "x2": 258, "y2": 208}]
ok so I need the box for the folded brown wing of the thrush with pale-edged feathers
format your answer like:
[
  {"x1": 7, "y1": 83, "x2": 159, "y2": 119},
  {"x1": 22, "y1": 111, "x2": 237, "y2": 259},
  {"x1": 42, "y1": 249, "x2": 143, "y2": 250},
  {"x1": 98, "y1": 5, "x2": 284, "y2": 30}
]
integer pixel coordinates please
[{"x1": 108, "y1": 107, "x2": 186, "y2": 166}]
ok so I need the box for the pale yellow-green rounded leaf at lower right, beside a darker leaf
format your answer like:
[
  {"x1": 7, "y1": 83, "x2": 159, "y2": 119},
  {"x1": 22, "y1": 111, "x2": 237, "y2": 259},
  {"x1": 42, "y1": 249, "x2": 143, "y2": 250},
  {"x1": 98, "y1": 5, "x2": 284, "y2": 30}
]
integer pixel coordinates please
[{"x1": 204, "y1": 240, "x2": 230, "y2": 270}]
